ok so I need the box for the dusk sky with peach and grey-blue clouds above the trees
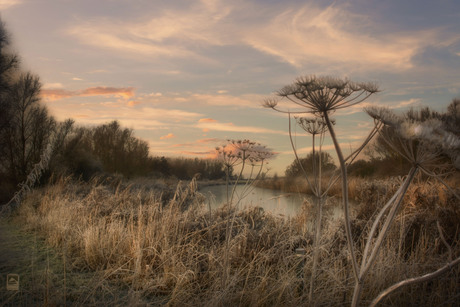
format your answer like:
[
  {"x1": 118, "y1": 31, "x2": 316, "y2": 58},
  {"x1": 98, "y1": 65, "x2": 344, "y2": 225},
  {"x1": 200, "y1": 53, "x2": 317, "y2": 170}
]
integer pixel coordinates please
[{"x1": 0, "y1": 0, "x2": 460, "y2": 175}]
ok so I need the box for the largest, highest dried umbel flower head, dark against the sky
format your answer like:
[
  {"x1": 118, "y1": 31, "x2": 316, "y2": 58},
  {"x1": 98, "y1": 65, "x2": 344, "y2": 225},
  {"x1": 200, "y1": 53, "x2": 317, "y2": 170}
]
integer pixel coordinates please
[{"x1": 264, "y1": 75, "x2": 379, "y2": 114}]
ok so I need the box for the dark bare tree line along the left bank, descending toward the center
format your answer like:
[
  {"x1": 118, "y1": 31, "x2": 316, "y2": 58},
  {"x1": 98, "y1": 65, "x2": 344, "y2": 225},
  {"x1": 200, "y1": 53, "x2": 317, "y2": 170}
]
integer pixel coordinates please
[{"x1": 0, "y1": 22, "x2": 225, "y2": 203}]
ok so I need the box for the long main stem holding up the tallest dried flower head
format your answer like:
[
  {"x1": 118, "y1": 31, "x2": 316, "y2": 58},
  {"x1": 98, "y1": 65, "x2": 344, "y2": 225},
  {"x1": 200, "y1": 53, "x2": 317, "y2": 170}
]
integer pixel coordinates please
[{"x1": 323, "y1": 112, "x2": 359, "y2": 281}]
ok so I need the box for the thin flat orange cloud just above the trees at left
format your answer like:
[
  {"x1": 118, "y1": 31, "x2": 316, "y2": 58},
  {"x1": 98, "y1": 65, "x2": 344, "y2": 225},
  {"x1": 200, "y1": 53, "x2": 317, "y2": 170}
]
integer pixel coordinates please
[{"x1": 41, "y1": 86, "x2": 135, "y2": 100}]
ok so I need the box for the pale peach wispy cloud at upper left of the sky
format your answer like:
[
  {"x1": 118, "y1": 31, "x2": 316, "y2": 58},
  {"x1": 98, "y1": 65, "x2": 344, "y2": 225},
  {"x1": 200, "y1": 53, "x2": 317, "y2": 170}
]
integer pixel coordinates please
[{"x1": 67, "y1": 1, "x2": 231, "y2": 60}]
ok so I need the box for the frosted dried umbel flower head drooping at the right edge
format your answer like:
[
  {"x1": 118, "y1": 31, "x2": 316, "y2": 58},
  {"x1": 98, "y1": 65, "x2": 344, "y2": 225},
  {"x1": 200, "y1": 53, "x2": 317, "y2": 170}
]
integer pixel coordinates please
[{"x1": 365, "y1": 107, "x2": 460, "y2": 168}]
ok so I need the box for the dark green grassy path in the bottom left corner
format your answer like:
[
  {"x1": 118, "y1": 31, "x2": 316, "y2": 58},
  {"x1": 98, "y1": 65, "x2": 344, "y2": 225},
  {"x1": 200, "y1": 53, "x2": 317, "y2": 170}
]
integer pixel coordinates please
[{"x1": 0, "y1": 218, "x2": 161, "y2": 307}]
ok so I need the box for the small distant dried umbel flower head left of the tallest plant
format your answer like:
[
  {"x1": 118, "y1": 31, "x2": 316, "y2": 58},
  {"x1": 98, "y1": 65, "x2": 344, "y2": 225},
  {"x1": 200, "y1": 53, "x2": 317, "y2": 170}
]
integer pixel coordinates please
[{"x1": 216, "y1": 139, "x2": 274, "y2": 167}]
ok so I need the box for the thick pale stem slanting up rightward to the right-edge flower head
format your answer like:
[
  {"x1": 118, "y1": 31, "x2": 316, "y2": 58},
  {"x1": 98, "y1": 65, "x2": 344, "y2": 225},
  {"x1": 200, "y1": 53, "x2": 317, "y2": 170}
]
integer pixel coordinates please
[{"x1": 351, "y1": 166, "x2": 418, "y2": 307}]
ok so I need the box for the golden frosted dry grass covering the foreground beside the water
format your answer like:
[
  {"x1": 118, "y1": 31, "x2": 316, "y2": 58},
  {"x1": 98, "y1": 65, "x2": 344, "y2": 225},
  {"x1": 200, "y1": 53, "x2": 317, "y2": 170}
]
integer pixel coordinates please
[{"x1": 9, "y1": 180, "x2": 460, "y2": 306}]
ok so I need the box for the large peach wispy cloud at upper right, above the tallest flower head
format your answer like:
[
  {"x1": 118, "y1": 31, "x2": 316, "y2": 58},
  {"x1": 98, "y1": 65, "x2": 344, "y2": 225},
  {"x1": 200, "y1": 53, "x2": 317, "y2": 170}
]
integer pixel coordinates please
[{"x1": 244, "y1": 4, "x2": 435, "y2": 70}]
